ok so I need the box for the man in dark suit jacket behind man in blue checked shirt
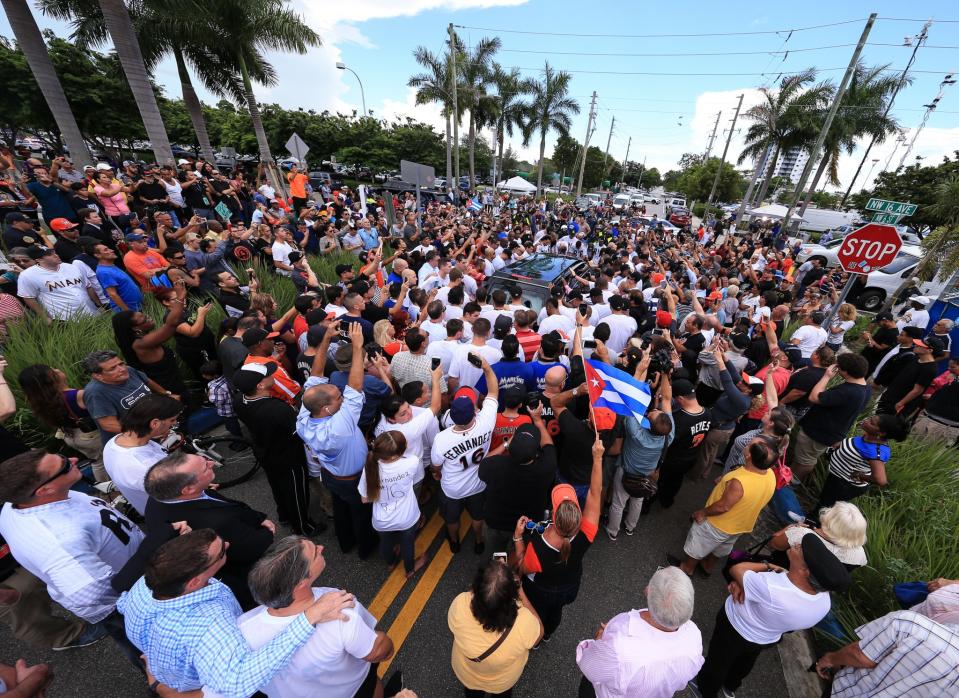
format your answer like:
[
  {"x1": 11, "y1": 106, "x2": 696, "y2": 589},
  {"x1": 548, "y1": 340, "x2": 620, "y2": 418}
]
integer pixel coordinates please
[{"x1": 113, "y1": 451, "x2": 276, "y2": 610}]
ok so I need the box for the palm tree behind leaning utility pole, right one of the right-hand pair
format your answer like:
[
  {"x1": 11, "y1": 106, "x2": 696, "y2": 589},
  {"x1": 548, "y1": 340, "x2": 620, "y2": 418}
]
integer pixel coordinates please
[{"x1": 799, "y1": 63, "x2": 901, "y2": 216}]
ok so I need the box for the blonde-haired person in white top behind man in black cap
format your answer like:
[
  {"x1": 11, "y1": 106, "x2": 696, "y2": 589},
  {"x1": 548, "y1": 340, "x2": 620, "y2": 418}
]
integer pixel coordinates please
[{"x1": 769, "y1": 502, "x2": 867, "y2": 570}]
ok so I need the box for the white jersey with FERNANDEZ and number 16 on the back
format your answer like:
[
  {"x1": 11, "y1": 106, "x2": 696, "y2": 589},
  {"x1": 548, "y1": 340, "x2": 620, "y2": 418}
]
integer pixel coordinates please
[{"x1": 431, "y1": 397, "x2": 498, "y2": 499}]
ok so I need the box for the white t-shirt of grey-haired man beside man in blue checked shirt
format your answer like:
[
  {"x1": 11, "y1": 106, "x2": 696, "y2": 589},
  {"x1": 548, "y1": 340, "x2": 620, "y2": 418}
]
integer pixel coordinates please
[{"x1": 236, "y1": 587, "x2": 376, "y2": 698}]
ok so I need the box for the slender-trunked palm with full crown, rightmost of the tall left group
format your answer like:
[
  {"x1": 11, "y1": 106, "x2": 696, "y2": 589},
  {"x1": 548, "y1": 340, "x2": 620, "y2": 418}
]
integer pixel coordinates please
[{"x1": 201, "y1": 0, "x2": 321, "y2": 191}]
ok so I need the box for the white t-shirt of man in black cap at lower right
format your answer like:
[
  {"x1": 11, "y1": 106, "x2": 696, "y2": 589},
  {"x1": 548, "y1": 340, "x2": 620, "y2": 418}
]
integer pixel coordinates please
[{"x1": 726, "y1": 570, "x2": 830, "y2": 645}]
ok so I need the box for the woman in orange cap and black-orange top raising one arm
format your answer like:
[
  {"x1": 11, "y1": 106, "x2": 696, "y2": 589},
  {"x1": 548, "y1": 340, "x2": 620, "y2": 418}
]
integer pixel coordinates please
[{"x1": 513, "y1": 435, "x2": 605, "y2": 642}]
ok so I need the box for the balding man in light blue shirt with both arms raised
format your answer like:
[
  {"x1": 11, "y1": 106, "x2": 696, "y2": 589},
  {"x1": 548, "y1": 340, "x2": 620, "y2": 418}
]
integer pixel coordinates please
[{"x1": 296, "y1": 322, "x2": 376, "y2": 559}]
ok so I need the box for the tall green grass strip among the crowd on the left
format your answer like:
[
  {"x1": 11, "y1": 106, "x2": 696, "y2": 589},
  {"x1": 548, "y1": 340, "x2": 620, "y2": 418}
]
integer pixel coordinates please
[{"x1": 0, "y1": 252, "x2": 368, "y2": 446}]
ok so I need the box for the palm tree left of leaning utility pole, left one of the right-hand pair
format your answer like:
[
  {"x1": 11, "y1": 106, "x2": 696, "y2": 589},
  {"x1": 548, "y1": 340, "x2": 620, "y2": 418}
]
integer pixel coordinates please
[{"x1": 739, "y1": 68, "x2": 816, "y2": 203}]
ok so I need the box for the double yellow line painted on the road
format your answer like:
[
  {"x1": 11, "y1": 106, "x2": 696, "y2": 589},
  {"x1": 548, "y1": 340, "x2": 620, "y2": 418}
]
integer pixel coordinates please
[{"x1": 367, "y1": 512, "x2": 470, "y2": 678}]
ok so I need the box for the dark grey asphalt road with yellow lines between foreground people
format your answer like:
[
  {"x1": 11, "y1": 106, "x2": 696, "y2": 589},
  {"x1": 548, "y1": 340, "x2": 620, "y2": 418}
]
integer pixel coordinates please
[{"x1": 0, "y1": 456, "x2": 785, "y2": 698}]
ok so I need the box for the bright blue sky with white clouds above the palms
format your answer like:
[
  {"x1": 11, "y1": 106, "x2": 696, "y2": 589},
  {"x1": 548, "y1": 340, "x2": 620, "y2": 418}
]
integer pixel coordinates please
[{"x1": 0, "y1": 0, "x2": 959, "y2": 190}]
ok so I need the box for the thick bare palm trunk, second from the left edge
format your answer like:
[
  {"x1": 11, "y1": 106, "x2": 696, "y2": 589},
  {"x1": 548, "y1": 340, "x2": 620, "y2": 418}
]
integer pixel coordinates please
[{"x1": 99, "y1": 0, "x2": 174, "y2": 165}]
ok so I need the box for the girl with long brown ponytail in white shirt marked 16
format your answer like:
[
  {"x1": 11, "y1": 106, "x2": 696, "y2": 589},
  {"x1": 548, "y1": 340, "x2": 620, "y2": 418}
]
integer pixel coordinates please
[{"x1": 357, "y1": 431, "x2": 426, "y2": 579}]
